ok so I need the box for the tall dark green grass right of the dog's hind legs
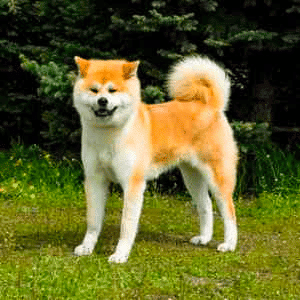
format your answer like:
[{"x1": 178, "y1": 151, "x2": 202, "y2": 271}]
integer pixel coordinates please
[{"x1": 235, "y1": 143, "x2": 300, "y2": 195}]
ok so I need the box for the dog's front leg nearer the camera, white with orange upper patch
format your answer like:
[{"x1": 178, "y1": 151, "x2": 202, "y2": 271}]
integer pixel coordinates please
[{"x1": 109, "y1": 176, "x2": 146, "y2": 263}]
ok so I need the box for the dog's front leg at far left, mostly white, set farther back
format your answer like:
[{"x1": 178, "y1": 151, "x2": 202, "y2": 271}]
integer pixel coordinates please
[{"x1": 74, "y1": 174, "x2": 108, "y2": 256}]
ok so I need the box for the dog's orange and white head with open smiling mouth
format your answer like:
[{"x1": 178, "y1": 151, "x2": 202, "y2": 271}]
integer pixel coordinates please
[{"x1": 74, "y1": 57, "x2": 140, "y2": 127}]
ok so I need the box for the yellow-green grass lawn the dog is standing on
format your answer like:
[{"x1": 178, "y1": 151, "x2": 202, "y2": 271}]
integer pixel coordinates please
[{"x1": 0, "y1": 147, "x2": 300, "y2": 300}]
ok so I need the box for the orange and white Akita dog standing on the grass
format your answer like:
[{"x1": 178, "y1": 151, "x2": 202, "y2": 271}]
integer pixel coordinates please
[{"x1": 73, "y1": 55, "x2": 238, "y2": 263}]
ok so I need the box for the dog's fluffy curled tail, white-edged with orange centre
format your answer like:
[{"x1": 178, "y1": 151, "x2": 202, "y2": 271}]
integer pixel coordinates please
[{"x1": 167, "y1": 56, "x2": 230, "y2": 110}]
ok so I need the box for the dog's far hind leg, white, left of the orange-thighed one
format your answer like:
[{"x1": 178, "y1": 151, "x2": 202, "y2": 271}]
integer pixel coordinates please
[{"x1": 180, "y1": 164, "x2": 213, "y2": 245}]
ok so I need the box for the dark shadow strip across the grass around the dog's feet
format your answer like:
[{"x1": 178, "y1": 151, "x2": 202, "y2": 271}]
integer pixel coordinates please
[{"x1": 14, "y1": 220, "x2": 218, "y2": 255}]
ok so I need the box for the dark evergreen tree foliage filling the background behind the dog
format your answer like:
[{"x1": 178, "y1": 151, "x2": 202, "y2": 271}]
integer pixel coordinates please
[{"x1": 0, "y1": 0, "x2": 300, "y2": 193}]
